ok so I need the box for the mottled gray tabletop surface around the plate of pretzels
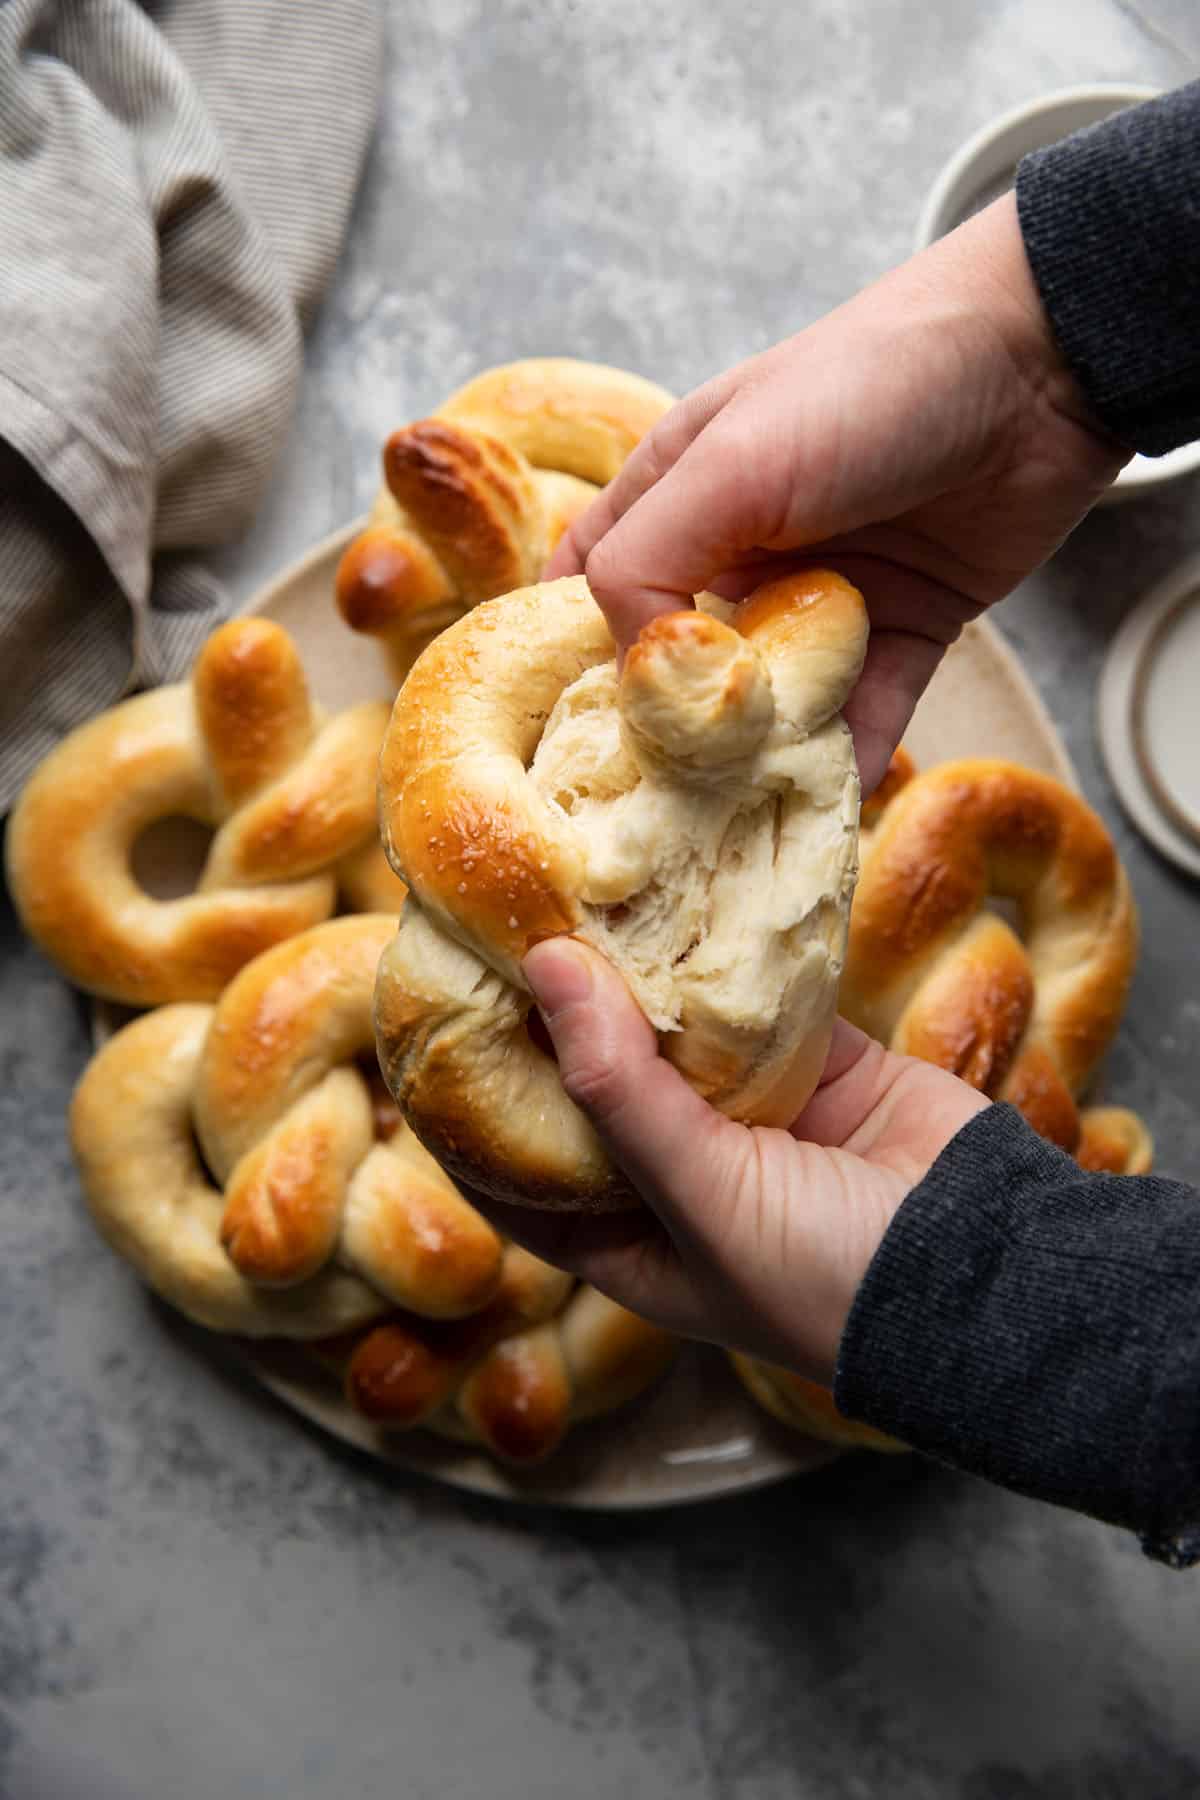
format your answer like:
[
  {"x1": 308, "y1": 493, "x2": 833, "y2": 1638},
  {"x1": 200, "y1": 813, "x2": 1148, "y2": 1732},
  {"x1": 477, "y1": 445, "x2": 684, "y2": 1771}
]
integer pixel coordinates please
[{"x1": 0, "y1": 0, "x2": 1200, "y2": 1800}]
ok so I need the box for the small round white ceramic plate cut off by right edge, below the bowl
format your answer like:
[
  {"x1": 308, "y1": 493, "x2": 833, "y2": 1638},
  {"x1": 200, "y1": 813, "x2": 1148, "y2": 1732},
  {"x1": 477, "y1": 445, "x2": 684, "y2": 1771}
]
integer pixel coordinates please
[{"x1": 1096, "y1": 556, "x2": 1200, "y2": 875}]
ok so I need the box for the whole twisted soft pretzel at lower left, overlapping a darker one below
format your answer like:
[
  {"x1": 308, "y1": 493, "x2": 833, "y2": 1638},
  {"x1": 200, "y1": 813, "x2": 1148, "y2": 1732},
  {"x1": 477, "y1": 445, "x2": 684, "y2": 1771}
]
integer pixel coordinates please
[{"x1": 70, "y1": 916, "x2": 502, "y2": 1337}]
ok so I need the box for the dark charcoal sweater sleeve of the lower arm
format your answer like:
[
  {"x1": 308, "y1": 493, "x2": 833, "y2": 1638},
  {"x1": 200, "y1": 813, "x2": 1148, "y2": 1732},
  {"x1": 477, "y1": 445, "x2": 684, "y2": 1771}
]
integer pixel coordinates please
[{"x1": 835, "y1": 1105, "x2": 1200, "y2": 1568}]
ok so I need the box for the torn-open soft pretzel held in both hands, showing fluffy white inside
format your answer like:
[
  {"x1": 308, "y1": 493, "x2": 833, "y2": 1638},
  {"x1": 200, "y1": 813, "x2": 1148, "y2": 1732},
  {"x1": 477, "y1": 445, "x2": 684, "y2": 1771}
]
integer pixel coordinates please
[{"x1": 376, "y1": 571, "x2": 867, "y2": 1210}]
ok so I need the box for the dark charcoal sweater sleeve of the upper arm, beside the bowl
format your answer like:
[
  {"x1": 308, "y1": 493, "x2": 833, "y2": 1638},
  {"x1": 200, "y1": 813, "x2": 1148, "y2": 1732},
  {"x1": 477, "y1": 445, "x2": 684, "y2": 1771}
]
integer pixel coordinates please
[{"x1": 1016, "y1": 81, "x2": 1200, "y2": 455}]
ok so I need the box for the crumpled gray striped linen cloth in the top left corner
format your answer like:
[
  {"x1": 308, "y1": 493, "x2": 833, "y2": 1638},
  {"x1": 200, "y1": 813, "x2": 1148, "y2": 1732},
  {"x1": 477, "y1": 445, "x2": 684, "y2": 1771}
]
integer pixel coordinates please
[{"x1": 0, "y1": 0, "x2": 380, "y2": 814}]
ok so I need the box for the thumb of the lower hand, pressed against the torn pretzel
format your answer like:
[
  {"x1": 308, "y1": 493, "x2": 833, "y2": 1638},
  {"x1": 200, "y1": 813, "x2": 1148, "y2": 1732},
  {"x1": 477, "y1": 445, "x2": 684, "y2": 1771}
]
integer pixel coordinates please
[{"x1": 524, "y1": 938, "x2": 745, "y2": 1235}]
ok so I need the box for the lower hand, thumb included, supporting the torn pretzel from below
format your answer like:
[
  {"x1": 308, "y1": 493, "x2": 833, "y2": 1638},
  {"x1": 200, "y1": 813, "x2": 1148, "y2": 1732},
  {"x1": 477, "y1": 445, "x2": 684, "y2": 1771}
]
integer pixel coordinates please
[{"x1": 477, "y1": 938, "x2": 988, "y2": 1384}]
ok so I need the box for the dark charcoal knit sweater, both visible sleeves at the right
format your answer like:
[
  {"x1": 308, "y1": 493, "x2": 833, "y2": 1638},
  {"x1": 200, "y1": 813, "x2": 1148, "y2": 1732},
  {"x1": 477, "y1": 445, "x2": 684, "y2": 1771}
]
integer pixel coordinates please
[{"x1": 835, "y1": 81, "x2": 1200, "y2": 1568}]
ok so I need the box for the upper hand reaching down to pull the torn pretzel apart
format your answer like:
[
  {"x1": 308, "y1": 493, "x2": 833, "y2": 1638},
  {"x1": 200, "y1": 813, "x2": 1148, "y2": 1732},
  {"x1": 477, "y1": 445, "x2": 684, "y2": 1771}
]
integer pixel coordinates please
[{"x1": 547, "y1": 194, "x2": 1130, "y2": 794}]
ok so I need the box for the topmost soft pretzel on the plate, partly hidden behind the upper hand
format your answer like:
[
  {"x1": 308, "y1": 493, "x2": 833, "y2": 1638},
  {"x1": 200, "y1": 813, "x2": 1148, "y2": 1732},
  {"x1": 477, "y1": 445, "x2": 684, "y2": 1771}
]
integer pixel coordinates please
[{"x1": 336, "y1": 356, "x2": 671, "y2": 680}]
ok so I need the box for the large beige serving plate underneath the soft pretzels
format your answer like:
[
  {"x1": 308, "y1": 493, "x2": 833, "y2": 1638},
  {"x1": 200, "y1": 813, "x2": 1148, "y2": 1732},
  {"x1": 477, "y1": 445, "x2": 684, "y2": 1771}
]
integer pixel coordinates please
[{"x1": 97, "y1": 524, "x2": 1074, "y2": 1510}]
